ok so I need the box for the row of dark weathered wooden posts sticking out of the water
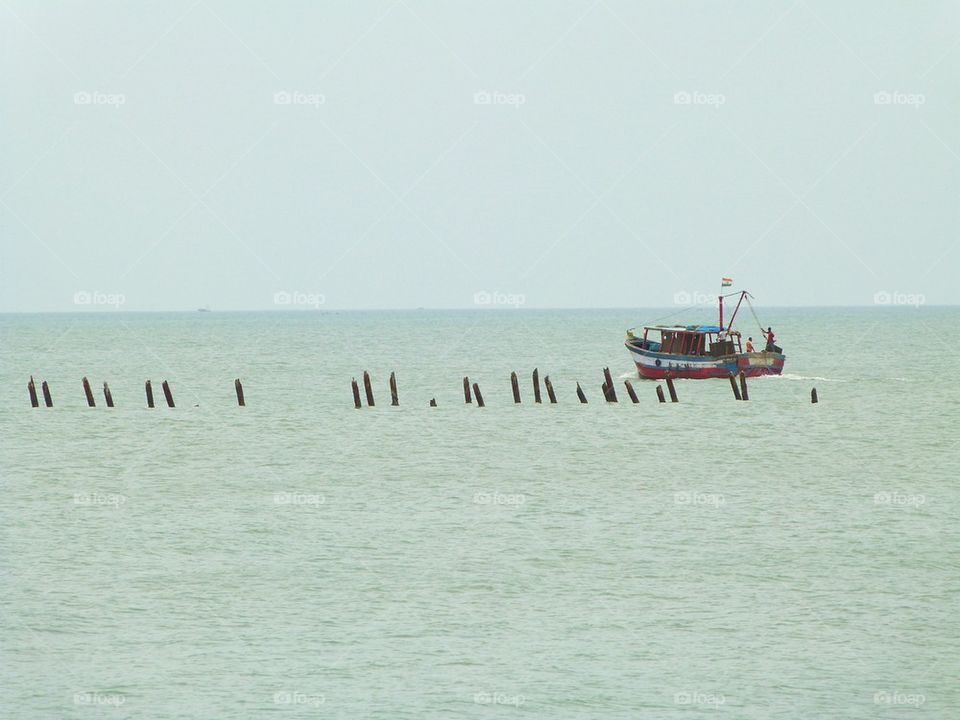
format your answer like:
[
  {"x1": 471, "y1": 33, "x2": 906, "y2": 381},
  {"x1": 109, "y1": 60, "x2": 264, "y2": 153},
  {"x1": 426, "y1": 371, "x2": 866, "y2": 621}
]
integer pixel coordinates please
[{"x1": 27, "y1": 367, "x2": 818, "y2": 409}]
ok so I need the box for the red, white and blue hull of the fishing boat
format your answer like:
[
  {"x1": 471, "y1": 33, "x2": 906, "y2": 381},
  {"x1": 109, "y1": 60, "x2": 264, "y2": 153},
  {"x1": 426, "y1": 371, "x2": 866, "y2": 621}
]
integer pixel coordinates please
[{"x1": 626, "y1": 343, "x2": 786, "y2": 380}]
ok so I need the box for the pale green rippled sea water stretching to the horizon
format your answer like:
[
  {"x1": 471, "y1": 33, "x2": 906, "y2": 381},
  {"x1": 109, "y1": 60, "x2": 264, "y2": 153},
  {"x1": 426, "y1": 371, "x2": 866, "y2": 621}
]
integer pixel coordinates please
[{"x1": 0, "y1": 307, "x2": 960, "y2": 720}]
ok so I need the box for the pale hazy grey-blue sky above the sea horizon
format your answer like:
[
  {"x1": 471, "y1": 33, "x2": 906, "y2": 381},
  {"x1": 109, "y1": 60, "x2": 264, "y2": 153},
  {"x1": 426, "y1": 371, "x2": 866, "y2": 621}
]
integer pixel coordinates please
[{"x1": 0, "y1": 0, "x2": 960, "y2": 311}]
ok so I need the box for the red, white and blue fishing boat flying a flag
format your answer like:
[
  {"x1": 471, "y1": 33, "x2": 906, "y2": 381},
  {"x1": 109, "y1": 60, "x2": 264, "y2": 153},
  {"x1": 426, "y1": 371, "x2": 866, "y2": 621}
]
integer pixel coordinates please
[{"x1": 625, "y1": 286, "x2": 786, "y2": 380}]
